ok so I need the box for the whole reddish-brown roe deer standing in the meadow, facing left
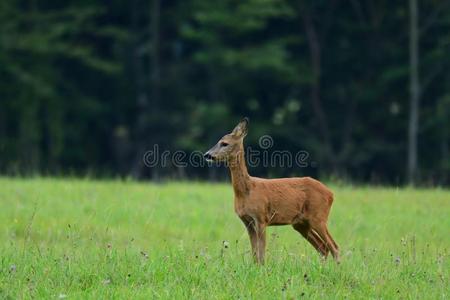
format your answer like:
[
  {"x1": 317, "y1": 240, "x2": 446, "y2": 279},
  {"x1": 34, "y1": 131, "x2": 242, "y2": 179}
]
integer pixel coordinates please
[{"x1": 204, "y1": 118, "x2": 339, "y2": 264}]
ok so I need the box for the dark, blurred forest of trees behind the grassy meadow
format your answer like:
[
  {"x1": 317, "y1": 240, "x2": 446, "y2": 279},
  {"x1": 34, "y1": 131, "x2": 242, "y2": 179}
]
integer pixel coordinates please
[{"x1": 0, "y1": 0, "x2": 450, "y2": 184}]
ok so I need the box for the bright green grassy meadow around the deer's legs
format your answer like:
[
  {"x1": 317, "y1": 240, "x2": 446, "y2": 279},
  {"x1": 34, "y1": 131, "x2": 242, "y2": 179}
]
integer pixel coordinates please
[{"x1": 0, "y1": 178, "x2": 450, "y2": 299}]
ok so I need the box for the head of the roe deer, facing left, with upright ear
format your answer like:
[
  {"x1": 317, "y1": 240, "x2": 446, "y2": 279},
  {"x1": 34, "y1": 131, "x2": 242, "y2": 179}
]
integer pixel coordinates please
[{"x1": 204, "y1": 118, "x2": 249, "y2": 162}]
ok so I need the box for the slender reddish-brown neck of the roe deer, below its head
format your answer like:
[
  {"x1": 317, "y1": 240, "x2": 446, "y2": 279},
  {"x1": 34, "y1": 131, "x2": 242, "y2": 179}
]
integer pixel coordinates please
[{"x1": 229, "y1": 146, "x2": 250, "y2": 198}]
